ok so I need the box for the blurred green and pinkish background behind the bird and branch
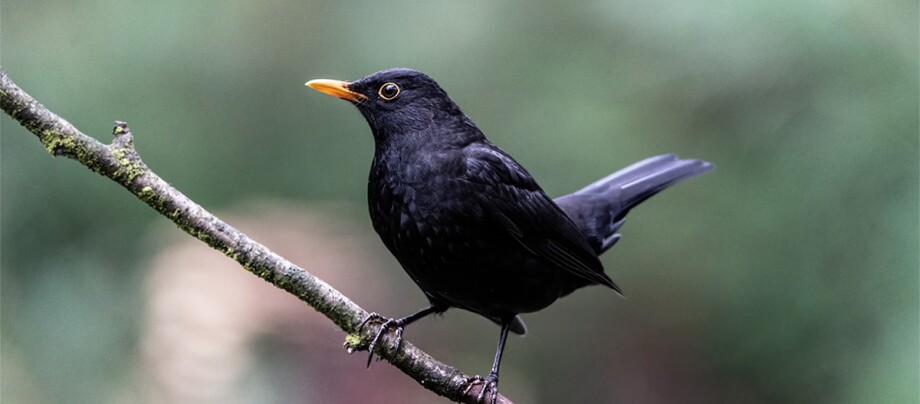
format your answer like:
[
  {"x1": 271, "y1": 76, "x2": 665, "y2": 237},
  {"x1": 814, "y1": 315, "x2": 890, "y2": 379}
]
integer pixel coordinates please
[{"x1": 0, "y1": 0, "x2": 920, "y2": 403}]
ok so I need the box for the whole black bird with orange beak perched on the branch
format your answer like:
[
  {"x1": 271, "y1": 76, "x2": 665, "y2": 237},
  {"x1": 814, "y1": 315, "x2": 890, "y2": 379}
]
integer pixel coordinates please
[{"x1": 307, "y1": 69, "x2": 713, "y2": 402}]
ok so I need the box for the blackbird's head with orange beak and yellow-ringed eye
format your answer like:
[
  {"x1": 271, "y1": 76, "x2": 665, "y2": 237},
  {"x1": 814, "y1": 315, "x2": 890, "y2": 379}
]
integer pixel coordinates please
[{"x1": 307, "y1": 69, "x2": 478, "y2": 141}]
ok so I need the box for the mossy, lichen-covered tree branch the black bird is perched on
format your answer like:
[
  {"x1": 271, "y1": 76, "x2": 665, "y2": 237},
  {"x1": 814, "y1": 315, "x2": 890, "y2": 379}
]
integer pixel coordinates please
[{"x1": 0, "y1": 67, "x2": 510, "y2": 403}]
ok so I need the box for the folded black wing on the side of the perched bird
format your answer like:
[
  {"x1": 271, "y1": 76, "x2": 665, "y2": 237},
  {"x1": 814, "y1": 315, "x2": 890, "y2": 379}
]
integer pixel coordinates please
[{"x1": 464, "y1": 143, "x2": 620, "y2": 292}]
